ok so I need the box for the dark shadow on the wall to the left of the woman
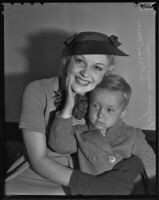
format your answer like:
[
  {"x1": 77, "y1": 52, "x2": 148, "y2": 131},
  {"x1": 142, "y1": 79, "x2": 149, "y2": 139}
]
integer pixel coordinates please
[{"x1": 5, "y1": 30, "x2": 72, "y2": 121}]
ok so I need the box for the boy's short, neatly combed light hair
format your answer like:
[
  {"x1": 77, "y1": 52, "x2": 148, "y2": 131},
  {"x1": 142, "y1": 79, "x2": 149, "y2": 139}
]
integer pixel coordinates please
[{"x1": 92, "y1": 73, "x2": 131, "y2": 107}]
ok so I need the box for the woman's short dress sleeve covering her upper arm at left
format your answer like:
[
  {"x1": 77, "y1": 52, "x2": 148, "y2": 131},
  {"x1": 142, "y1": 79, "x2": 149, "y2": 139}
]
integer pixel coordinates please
[{"x1": 19, "y1": 81, "x2": 46, "y2": 133}]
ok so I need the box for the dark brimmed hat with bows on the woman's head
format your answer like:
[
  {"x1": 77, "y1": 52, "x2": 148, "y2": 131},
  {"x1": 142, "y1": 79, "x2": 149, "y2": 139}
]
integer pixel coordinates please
[{"x1": 62, "y1": 31, "x2": 128, "y2": 57}]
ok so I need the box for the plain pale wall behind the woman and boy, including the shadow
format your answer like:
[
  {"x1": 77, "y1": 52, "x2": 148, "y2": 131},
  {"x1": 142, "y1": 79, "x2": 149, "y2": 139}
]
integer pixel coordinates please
[{"x1": 3, "y1": 2, "x2": 156, "y2": 129}]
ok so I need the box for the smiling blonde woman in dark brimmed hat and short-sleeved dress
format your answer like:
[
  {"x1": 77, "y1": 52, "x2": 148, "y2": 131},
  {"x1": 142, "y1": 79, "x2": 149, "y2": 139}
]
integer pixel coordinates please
[{"x1": 5, "y1": 32, "x2": 143, "y2": 195}]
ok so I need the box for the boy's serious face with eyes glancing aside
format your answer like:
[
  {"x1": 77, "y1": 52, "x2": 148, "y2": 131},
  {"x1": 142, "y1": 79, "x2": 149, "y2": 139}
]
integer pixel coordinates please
[{"x1": 89, "y1": 88, "x2": 124, "y2": 131}]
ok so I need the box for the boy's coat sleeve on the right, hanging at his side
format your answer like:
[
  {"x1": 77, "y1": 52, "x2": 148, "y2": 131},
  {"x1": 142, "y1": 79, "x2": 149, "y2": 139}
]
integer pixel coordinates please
[{"x1": 133, "y1": 129, "x2": 156, "y2": 178}]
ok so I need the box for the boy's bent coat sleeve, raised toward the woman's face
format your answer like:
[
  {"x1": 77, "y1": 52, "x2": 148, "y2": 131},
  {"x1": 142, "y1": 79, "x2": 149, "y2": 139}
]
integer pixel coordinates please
[{"x1": 49, "y1": 113, "x2": 77, "y2": 154}]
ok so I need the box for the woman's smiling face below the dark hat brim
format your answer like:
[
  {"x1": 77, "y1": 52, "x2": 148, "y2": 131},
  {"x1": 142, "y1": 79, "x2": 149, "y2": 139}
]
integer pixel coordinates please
[{"x1": 67, "y1": 54, "x2": 109, "y2": 94}]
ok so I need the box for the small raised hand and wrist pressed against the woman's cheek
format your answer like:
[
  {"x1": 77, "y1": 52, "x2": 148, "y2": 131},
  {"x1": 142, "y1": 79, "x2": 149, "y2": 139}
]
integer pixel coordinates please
[{"x1": 60, "y1": 74, "x2": 76, "y2": 118}]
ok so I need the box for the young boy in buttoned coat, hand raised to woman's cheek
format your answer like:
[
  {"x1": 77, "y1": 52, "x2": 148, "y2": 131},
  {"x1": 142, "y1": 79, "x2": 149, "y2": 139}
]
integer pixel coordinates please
[{"x1": 49, "y1": 74, "x2": 156, "y2": 180}]
